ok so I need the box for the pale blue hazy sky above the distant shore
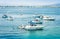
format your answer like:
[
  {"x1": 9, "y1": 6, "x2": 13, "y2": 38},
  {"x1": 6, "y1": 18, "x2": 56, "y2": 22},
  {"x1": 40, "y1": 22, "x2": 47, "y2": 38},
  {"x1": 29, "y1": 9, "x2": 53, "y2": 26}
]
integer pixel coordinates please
[{"x1": 0, "y1": 0, "x2": 60, "y2": 6}]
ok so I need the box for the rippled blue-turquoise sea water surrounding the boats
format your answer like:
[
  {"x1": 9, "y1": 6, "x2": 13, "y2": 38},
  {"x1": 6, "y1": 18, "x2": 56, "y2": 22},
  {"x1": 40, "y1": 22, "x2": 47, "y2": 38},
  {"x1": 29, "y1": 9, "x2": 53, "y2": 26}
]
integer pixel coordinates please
[{"x1": 0, "y1": 7, "x2": 60, "y2": 39}]
